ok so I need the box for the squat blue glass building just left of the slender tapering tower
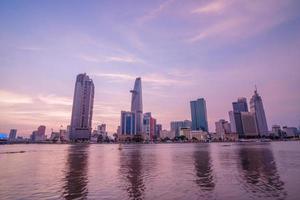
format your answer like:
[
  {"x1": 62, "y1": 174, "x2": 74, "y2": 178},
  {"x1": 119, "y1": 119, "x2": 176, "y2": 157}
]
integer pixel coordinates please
[{"x1": 121, "y1": 111, "x2": 136, "y2": 135}]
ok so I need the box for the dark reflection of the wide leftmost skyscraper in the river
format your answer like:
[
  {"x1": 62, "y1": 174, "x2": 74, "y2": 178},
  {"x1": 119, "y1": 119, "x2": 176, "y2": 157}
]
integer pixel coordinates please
[{"x1": 63, "y1": 145, "x2": 89, "y2": 199}]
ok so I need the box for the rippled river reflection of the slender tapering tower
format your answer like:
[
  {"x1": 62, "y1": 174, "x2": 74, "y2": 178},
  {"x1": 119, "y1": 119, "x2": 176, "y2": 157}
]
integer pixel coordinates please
[{"x1": 120, "y1": 145, "x2": 145, "y2": 199}]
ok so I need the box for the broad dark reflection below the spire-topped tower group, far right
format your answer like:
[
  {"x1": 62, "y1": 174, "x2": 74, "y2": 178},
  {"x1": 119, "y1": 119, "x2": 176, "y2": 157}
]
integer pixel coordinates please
[{"x1": 238, "y1": 147, "x2": 286, "y2": 199}]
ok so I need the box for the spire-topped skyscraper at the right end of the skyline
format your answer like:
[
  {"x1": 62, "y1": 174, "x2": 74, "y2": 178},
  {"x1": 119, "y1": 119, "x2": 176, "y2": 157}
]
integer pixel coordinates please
[{"x1": 250, "y1": 89, "x2": 269, "y2": 136}]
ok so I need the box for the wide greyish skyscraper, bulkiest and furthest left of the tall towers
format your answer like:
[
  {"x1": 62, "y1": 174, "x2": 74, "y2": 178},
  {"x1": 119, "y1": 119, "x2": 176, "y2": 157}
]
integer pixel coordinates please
[{"x1": 70, "y1": 73, "x2": 94, "y2": 141}]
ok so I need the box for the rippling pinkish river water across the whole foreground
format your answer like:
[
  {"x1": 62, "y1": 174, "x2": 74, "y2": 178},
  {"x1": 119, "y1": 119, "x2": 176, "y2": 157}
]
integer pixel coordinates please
[{"x1": 0, "y1": 142, "x2": 300, "y2": 200}]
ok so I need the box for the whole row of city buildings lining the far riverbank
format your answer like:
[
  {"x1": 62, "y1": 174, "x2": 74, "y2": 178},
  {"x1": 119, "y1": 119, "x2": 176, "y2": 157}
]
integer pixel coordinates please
[{"x1": 0, "y1": 73, "x2": 299, "y2": 142}]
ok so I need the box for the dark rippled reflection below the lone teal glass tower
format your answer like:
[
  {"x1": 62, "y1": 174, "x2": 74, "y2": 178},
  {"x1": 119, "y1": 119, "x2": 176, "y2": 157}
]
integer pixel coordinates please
[{"x1": 194, "y1": 146, "x2": 215, "y2": 191}]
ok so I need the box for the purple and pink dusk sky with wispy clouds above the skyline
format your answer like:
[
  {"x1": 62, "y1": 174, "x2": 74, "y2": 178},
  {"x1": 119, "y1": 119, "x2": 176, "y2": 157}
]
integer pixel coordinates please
[{"x1": 0, "y1": 0, "x2": 300, "y2": 136}]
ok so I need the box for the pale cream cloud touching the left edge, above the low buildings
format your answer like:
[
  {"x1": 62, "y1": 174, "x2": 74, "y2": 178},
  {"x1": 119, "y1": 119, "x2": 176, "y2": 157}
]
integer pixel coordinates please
[{"x1": 0, "y1": 90, "x2": 33, "y2": 104}]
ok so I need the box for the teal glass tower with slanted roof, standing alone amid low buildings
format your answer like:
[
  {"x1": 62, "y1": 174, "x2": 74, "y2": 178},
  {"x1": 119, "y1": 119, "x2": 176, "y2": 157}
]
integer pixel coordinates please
[{"x1": 190, "y1": 98, "x2": 208, "y2": 132}]
